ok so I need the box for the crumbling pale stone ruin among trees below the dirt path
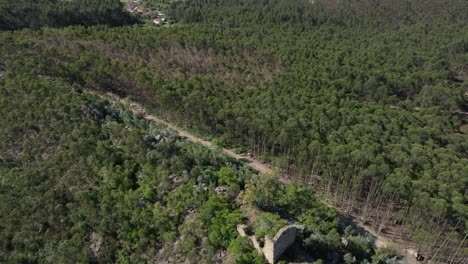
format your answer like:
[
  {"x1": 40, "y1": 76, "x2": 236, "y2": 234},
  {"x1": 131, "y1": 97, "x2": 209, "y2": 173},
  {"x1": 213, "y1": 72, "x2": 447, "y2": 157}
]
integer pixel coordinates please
[{"x1": 237, "y1": 225, "x2": 305, "y2": 264}]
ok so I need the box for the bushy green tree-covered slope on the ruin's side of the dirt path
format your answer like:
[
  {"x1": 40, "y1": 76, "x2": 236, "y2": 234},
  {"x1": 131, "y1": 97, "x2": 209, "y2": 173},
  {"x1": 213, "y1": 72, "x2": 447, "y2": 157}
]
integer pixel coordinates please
[{"x1": 0, "y1": 74, "x2": 402, "y2": 263}]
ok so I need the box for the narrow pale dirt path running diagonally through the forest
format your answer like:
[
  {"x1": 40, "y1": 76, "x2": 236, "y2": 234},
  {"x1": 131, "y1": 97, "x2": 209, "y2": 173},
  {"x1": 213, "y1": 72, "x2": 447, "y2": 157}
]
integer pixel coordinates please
[{"x1": 101, "y1": 93, "x2": 418, "y2": 264}]
